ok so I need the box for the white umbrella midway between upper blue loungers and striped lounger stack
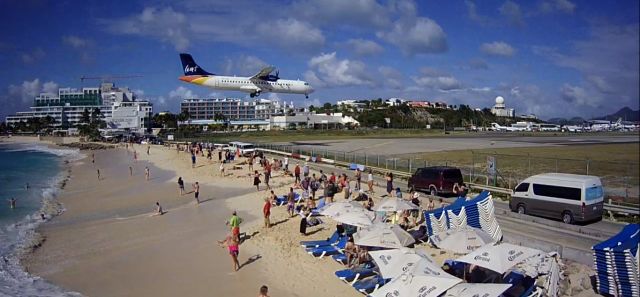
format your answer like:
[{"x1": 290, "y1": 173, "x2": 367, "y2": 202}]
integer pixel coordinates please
[{"x1": 353, "y1": 223, "x2": 415, "y2": 249}]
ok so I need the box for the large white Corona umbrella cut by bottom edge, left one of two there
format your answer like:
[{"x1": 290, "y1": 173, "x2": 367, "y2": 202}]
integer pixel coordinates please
[{"x1": 370, "y1": 260, "x2": 462, "y2": 297}]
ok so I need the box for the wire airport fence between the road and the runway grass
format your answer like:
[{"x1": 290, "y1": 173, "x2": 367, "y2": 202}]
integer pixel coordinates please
[{"x1": 252, "y1": 144, "x2": 640, "y2": 204}]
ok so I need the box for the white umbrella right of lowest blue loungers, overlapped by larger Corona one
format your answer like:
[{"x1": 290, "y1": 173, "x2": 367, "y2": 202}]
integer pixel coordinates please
[{"x1": 369, "y1": 248, "x2": 445, "y2": 278}]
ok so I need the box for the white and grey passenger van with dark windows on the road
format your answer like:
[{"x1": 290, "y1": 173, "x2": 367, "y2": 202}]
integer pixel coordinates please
[{"x1": 509, "y1": 173, "x2": 604, "y2": 224}]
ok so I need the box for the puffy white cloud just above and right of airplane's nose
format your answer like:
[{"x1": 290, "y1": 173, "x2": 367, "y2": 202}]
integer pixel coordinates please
[{"x1": 304, "y1": 52, "x2": 373, "y2": 87}]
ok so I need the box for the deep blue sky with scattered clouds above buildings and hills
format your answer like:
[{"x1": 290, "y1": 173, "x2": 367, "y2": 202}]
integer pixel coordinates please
[{"x1": 0, "y1": 0, "x2": 640, "y2": 119}]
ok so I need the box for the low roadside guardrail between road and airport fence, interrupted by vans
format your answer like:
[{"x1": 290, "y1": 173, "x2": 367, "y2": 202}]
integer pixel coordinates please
[{"x1": 256, "y1": 148, "x2": 640, "y2": 216}]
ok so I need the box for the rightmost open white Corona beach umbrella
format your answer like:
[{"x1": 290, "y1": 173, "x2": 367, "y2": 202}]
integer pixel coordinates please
[{"x1": 456, "y1": 243, "x2": 542, "y2": 273}]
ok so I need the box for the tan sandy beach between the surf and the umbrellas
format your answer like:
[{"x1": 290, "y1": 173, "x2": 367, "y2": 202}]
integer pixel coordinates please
[{"x1": 16, "y1": 139, "x2": 590, "y2": 297}]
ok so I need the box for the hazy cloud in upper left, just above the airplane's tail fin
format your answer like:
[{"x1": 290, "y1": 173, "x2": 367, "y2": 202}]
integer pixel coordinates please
[{"x1": 103, "y1": 7, "x2": 190, "y2": 51}]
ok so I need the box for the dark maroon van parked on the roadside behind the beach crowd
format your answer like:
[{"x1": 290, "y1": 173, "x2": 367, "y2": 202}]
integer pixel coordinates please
[{"x1": 408, "y1": 166, "x2": 464, "y2": 196}]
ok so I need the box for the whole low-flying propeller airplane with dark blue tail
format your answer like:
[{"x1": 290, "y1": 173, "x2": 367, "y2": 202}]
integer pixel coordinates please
[{"x1": 179, "y1": 53, "x2": 314, "y2": 99}]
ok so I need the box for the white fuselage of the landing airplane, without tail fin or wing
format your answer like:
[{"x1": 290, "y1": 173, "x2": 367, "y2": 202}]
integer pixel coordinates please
[{"x1": 180, "y1": 75, "x2": 313, "y2": 96}]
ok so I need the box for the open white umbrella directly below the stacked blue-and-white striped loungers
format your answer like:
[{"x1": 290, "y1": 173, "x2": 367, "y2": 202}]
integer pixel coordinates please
[{"x1": 429, "y1": 227, "x2": 495, "y2": 254}]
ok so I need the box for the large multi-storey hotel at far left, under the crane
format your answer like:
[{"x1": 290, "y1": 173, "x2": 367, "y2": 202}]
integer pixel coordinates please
[{"x1": 5, "y1": 83, "x2": 153, "y2": 133}]
